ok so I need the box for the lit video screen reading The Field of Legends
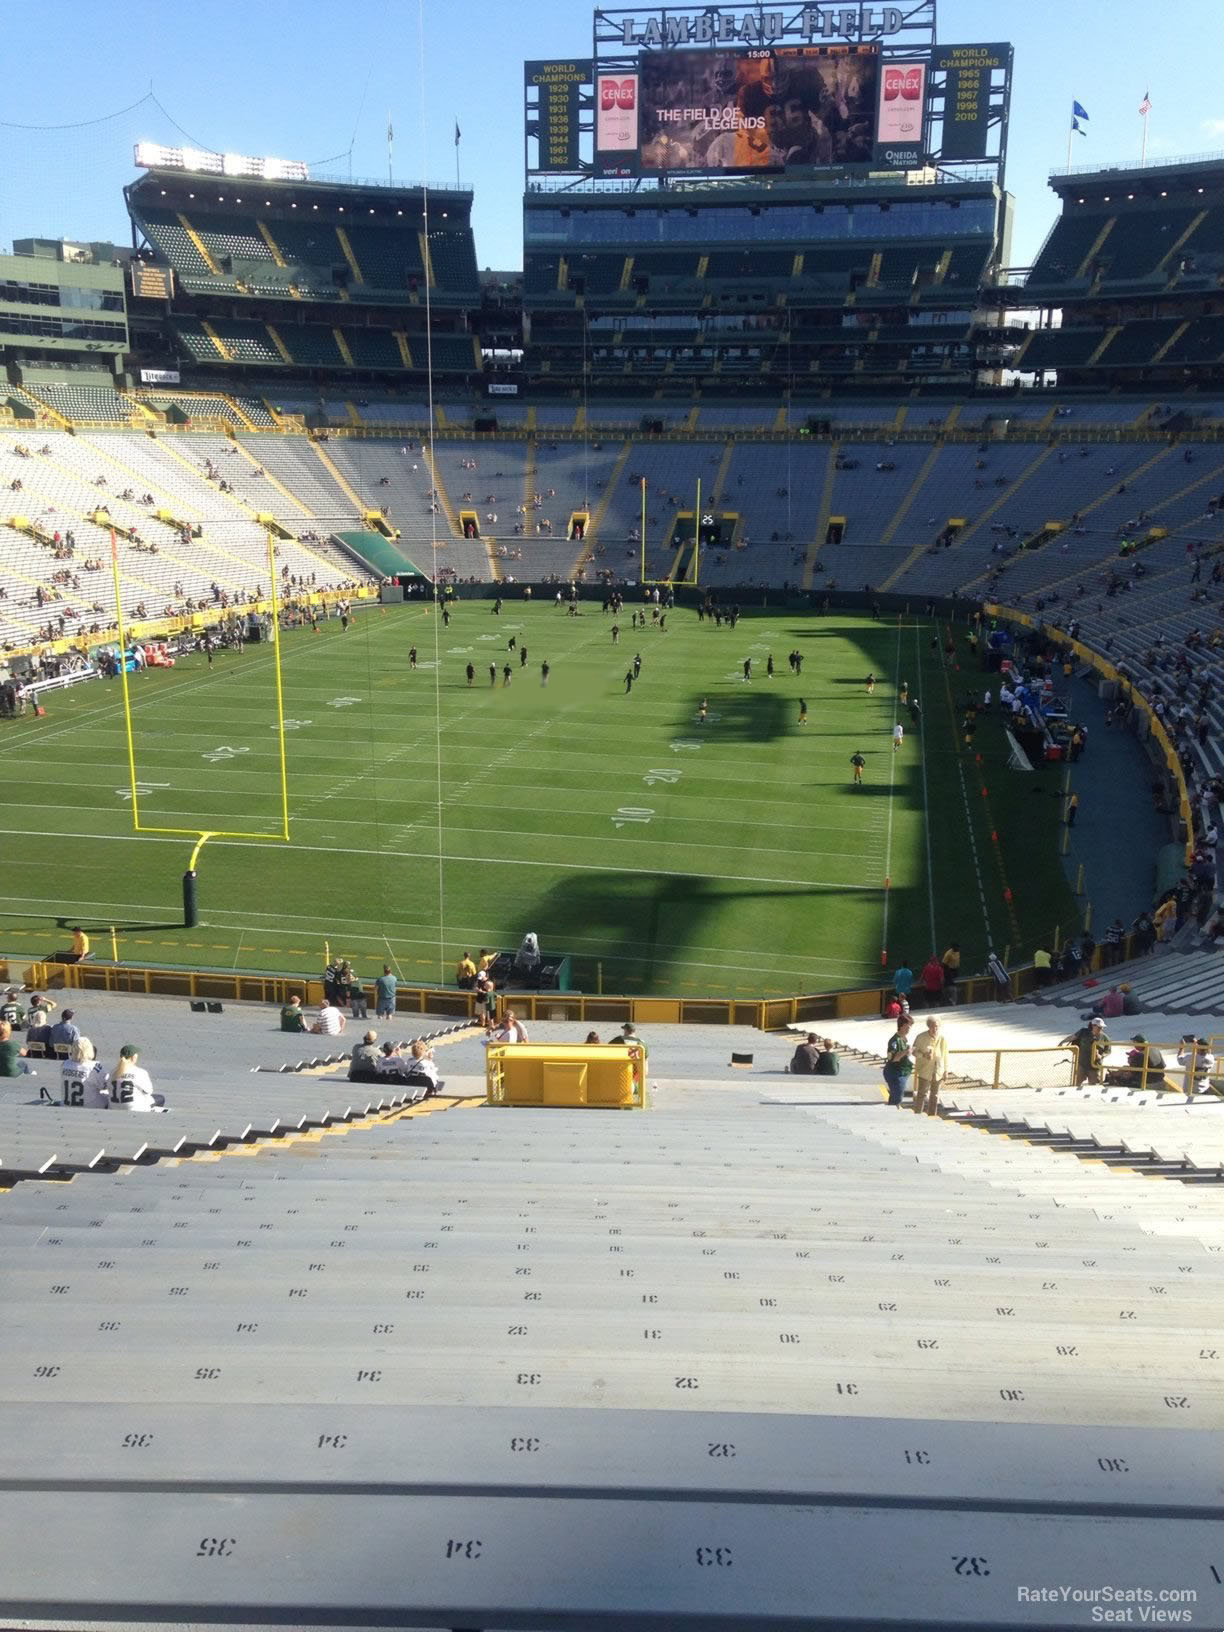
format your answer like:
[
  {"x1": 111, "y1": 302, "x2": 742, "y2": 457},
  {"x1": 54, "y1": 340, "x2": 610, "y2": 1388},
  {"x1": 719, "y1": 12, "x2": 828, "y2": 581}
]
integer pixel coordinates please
[{"x1": 638, "y1": 46, "x2": 880, "y2": 171}]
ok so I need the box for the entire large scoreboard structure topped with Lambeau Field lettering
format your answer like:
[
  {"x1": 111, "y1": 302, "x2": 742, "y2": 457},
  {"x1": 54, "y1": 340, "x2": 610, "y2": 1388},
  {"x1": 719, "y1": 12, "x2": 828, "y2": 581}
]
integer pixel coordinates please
[{"x1": 526, "y1": 0, "x2": 1012, "y2": 186}]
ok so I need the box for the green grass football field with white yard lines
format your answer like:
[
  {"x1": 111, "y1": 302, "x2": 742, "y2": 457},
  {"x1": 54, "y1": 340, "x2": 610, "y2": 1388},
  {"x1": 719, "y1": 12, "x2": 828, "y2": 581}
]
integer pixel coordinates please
[{"x1": 0, "y1": 601, "x2": 1074, "y2": 997}]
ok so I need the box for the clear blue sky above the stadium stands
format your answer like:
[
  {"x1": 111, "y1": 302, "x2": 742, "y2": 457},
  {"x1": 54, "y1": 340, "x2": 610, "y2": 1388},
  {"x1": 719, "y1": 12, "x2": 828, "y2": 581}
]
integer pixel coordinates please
[{"x1": 0, "y1": 0, "x2": 1224, "y2": 268}]
